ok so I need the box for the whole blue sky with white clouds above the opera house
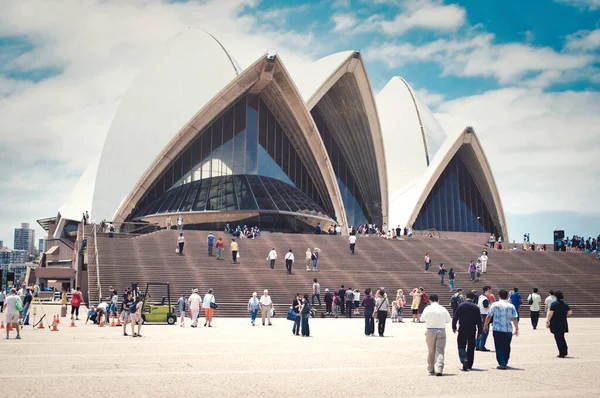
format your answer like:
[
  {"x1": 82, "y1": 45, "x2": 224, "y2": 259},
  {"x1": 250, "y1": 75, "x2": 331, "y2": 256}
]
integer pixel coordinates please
[{"x1": 0, "y1": 0, "x2": 600, "y2": 247}]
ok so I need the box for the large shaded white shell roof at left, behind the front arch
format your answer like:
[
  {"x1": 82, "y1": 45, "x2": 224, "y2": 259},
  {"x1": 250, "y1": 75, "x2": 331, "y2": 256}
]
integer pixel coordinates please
[{"x1": 90, "y1": 28, "x2": 239, "y2": 220}]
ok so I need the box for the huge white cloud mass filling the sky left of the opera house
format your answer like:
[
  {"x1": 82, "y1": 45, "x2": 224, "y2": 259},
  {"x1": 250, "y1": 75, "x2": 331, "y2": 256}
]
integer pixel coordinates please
[{"x1": 0, "y1": 0, "x2": 325, "y2": 244}]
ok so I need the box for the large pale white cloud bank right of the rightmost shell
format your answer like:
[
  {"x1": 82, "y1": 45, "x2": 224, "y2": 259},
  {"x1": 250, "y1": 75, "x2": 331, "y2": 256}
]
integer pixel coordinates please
[{"x1": 436, "y1": 88, "x2": 600, "y2": 213}]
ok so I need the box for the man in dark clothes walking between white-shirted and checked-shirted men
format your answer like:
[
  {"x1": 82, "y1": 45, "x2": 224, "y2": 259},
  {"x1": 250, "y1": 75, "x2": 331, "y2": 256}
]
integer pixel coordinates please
[{"x1": 452, "y1": 292, "x2": 483, "y2": 372}]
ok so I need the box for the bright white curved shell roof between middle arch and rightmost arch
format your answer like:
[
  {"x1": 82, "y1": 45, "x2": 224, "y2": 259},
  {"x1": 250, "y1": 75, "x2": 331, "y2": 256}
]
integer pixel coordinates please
[{"x1": 377, "y1": 77, "x2": 446, "y2": 196}]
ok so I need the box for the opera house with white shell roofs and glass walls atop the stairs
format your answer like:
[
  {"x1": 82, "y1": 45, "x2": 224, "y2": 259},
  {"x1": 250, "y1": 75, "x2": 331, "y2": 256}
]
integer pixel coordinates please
[{"x1": 40, "y1": 29, "x2": 507, "y2": 243}]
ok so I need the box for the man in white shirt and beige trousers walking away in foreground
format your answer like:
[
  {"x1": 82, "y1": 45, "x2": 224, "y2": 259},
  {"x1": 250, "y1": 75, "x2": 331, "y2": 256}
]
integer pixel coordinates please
[{"x1": 421, "y1": 294, "x2": 452, "y2": 376}]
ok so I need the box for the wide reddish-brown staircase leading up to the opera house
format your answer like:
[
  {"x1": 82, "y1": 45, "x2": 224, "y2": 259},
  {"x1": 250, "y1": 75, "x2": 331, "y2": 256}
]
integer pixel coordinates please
[{"x1": 89, "y1": 230, "x2": 600, "y2": 317}]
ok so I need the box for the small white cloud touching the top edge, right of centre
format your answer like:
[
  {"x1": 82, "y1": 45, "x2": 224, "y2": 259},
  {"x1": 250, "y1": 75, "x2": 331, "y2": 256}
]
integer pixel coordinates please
[{"x1": 356, "y1": 0, "x2": 466, "y2": 35}]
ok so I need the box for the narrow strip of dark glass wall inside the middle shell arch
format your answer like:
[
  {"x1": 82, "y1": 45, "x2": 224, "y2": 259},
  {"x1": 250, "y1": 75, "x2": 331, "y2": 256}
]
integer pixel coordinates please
[{"x1": 311, "y1": 110, "x2": 374, "y2": 226}]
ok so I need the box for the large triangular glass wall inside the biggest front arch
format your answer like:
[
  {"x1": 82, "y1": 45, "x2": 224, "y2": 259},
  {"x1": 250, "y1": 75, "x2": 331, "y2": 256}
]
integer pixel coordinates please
[{"x1": 133, "y1": 95, "x2": 334, "y2": 217}]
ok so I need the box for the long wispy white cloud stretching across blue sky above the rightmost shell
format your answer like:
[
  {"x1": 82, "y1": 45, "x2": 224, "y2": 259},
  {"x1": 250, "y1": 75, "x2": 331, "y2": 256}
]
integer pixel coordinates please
[{"x1": 367, "y1": 34, "x2": 595, "y2": 84}]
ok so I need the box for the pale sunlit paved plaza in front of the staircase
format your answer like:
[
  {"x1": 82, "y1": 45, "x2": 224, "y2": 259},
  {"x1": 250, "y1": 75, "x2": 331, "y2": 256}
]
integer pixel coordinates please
[{"x1": 0, "y1": 306, "x2": 600, "y2": 397}]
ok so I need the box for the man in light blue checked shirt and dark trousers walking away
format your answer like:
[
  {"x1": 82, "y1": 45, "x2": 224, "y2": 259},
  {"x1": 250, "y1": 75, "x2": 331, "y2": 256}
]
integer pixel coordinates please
[{"x1": 483, "y1": 290, "x2": 519, "y2": 370}]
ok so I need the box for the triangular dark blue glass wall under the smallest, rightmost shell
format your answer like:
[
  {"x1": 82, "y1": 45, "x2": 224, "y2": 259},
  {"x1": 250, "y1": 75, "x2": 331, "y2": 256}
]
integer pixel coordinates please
[{"x1": 413, "y1": 155, "x2": 500, "y2": 236}]
